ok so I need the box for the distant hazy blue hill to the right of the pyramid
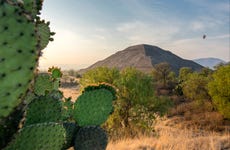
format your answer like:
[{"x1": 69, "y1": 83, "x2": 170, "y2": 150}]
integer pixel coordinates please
[{"x1": 193, "y1": 58, "x2": 226, "y2": 69}]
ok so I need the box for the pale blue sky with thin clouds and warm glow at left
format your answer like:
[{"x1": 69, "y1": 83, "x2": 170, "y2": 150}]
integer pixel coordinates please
[{"x1": 39, "y1": 0, "x2": 230, "y2": 70}]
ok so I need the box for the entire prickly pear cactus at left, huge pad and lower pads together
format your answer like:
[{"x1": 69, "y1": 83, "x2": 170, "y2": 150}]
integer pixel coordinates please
[{"x1": 0, "y1": 0, "x2": 116, "y2": 150}]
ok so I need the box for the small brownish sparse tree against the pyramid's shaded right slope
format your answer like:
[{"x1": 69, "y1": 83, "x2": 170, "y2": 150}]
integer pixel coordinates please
[{"x1": 153, "y1": 62, "x2": 171, "y2": 87}]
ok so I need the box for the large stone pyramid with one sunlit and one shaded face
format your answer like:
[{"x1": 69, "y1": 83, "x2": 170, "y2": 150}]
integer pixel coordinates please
[{"x1": 79, "y1": 44, "x2": 202, "y2": 73}]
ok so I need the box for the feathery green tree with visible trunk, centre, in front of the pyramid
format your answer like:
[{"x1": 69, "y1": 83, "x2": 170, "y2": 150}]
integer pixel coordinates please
[{"x1": 115, "y1": 68, "x2": 154, "y2": 129}]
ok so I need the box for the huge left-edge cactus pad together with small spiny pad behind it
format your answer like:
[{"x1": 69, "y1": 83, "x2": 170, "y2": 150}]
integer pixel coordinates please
[{"x1": 0, "y1": 0, "x2": 54, "y2": 118}]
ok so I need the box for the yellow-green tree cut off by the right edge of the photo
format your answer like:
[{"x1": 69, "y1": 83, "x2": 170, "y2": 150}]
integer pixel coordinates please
[{"x1": 208, "y1": 64, "x2": 230, "y2": 119}]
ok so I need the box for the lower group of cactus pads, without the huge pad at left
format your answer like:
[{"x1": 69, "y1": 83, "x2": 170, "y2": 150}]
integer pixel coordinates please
[{"x1": 5, "y1": 68, "x2": 116, "y2": 150}]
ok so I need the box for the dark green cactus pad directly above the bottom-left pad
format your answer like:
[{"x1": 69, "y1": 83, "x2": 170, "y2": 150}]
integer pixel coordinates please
[{"x1": 25, "y1": 96, "x2": 62, "y2": 126}]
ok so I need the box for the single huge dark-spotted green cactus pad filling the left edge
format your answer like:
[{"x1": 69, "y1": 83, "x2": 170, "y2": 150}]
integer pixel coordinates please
[{"x1": 0, "y1": 1, "x2": 38, "y2": 118}]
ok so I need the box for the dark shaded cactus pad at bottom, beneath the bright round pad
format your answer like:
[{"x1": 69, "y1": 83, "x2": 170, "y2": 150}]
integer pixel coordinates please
[{"x1": 74, "y1": 126, "x2": 108, "y2": 150}]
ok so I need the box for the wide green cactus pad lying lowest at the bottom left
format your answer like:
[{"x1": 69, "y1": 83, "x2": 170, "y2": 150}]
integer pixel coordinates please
[{"x1": 5, "y1": 123, "x2": 66, "y2": 150}]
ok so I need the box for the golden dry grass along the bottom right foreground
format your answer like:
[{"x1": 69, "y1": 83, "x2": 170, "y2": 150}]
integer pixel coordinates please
[{"x1": 107, "y1": 116, "x2": 230, "y2": 150}]
